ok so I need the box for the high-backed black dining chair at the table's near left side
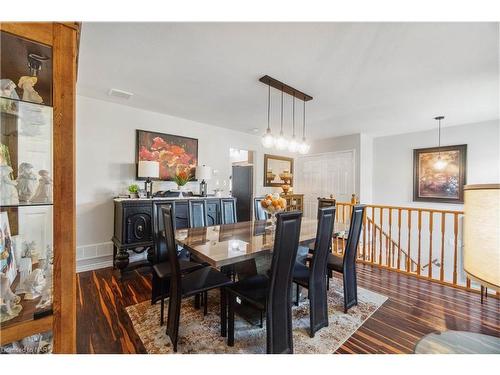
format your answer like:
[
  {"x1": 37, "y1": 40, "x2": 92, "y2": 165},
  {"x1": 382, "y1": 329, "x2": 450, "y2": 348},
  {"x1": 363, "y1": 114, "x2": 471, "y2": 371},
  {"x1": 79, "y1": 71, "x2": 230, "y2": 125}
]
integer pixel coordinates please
[{"x1": 161, "y1": 206, "x2": 232, "y2": 352}]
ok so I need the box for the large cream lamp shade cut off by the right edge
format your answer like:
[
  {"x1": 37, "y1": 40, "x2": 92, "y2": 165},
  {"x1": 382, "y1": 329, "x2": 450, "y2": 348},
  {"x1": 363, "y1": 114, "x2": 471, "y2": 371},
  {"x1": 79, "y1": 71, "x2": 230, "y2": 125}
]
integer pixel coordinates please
[{"x1": 464, "y1": 184, "x2": 500, "y2": 290}]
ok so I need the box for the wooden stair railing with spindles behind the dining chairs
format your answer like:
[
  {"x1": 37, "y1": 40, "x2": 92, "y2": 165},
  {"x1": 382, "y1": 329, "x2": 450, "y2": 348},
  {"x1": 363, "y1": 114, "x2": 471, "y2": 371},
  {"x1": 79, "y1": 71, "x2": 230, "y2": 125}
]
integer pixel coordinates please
[{"x1": 333, "y1": 202, "x2": 500, "y2": 297}]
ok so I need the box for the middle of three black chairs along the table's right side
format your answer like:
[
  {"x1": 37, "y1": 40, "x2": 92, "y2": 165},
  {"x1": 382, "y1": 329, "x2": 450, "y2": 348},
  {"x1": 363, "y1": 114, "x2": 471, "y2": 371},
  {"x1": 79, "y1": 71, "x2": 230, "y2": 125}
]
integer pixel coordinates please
[{"x1": 293, "y1": 207, "x2": 335, "y2": 337}]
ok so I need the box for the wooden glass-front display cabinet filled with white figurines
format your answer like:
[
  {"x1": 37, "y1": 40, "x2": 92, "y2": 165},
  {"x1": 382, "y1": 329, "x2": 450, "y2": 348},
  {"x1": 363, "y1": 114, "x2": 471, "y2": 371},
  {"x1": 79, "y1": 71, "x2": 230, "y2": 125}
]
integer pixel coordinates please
[{"x1": 0, "y1": 23, "x2": 79, "y2": 353}]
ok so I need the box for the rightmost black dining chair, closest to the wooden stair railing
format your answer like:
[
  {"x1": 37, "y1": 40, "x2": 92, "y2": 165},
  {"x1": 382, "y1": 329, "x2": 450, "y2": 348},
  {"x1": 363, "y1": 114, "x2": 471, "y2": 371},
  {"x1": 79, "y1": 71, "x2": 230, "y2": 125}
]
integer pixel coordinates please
[{"x1": 327, "y1": 205, "x2": 365, "y2": 313}]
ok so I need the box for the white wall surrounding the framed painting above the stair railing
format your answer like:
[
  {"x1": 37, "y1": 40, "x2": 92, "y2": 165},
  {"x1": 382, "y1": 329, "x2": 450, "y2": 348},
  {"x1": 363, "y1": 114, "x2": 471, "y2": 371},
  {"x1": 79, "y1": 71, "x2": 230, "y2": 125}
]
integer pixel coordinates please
[{"x1": 373, "y1": 120, "x2": 500, "y2": 210}]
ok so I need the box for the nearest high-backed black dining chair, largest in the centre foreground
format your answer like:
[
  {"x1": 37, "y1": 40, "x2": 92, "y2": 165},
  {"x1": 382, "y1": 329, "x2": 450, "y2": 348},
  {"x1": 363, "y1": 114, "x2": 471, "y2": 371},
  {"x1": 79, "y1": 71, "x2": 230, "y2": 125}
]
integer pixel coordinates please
[{"x1": 227, "y1": 211, "x2": 302, "y2": 354}]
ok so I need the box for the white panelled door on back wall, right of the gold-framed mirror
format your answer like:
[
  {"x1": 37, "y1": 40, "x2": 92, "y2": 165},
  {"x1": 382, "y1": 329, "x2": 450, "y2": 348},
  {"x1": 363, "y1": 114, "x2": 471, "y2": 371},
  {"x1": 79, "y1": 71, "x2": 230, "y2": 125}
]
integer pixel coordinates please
[{"x1": 294, "y1": 150, "x2": 356, "y2": 218}]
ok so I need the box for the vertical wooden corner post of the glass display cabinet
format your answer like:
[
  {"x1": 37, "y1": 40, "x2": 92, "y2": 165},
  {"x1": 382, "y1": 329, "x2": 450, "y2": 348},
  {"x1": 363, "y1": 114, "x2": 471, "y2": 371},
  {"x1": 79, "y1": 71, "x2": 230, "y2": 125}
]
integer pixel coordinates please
[{"x1": 53, "y1": 23, "x2": 77, "y2": 353}]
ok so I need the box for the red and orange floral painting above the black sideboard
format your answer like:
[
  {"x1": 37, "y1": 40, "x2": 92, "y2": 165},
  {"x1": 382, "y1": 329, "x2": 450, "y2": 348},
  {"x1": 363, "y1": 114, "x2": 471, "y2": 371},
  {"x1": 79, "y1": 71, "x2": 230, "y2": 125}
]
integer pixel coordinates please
[{"x1": 136, "y1": 130, "x2": 198, "y2": 181}]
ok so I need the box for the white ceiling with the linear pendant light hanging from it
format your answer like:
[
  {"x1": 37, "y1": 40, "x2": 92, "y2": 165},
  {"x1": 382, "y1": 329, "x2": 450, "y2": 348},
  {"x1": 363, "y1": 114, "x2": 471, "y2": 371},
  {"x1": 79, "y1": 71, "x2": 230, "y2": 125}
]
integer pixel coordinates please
[{"x1": 78, "y1": 23, "x2": 499, "y2": 139}]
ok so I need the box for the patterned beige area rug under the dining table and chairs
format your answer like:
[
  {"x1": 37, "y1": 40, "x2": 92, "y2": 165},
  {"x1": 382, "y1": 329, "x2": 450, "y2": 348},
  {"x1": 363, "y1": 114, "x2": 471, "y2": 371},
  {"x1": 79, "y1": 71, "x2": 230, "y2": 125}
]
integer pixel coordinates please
[{"x1": 126, "y1": 278, "x2": 387, "y2": 354}]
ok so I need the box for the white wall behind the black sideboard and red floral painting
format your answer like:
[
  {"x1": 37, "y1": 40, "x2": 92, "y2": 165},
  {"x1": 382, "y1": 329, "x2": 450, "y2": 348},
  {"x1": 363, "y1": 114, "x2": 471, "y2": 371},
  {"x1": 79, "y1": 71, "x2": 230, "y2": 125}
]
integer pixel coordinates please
[{"x1": 77, "y1": 96, "x2": 286, "y2": 270}]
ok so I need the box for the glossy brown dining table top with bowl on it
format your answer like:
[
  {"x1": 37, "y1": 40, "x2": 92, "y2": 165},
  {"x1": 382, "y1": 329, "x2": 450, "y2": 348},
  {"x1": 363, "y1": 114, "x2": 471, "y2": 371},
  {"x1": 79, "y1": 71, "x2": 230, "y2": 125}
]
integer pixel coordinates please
[{"x1": 175, "y1": 218, "x2": 348, "y2": 268}]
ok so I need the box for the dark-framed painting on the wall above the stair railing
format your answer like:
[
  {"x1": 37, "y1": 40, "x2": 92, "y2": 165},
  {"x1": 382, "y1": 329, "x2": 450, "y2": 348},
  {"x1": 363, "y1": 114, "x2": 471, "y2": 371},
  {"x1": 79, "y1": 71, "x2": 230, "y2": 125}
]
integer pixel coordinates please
[{"x1": 413, "y1": 145, "x2": 467, "y2": 203}]
